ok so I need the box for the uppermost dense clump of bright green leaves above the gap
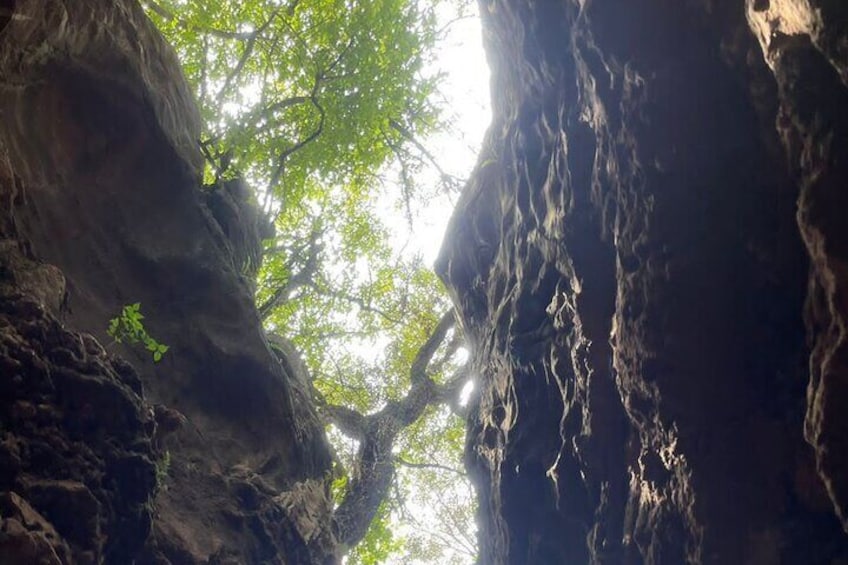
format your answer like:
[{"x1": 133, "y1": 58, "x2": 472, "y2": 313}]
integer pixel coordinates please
[{"x1": 147, "y1": 0, "x2": 437, "y2": 208}]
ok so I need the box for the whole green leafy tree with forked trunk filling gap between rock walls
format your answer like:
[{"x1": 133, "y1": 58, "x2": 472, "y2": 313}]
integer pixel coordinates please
[{"x1": 143, "y1": 0, "x2": 476, "y2": 564}]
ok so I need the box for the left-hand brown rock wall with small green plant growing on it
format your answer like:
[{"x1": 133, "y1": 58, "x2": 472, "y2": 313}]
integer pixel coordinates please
[{"x1": 0, "y1": 0, "x2": 335, "y2": 565}]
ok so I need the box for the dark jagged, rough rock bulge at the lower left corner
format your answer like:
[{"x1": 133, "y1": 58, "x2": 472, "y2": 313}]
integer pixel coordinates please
[{"x1": 0, "y1": 240, "x2": 157, "y2": 565}]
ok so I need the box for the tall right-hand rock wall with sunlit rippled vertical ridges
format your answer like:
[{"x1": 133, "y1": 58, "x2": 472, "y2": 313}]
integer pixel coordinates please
[{"x1": 437, "y1": 0, "x2": 848, "y2": 564}]
